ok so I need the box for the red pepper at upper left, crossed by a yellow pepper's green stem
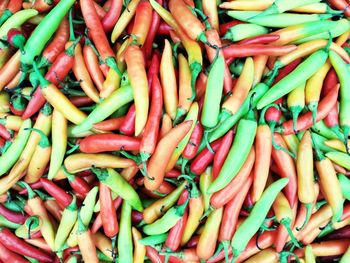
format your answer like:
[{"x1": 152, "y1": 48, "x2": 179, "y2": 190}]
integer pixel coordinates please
[{"x1": 22, "y1": 43, "x2": 74, "y2": 120}]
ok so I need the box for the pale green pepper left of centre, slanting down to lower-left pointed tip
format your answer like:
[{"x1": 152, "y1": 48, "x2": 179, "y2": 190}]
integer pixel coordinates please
[{"x1": 71, "y1": 86, "x2": 133, "y2": 135}]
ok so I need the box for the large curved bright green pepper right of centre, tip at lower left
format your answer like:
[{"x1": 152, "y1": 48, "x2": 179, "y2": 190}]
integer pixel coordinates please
[{"x1": 208, "y1": 111, "x2": 257, "y2": 193}]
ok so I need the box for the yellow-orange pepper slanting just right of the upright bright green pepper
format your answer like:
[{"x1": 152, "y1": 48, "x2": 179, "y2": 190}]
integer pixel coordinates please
[{"x1": 221, "y1": 57, "x2": 254, "y2": 120}]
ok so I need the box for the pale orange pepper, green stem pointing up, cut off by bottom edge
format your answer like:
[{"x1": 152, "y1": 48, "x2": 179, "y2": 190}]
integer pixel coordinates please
[{"x1": 77, "y1": 212, "x2": 99, "y2": 263}]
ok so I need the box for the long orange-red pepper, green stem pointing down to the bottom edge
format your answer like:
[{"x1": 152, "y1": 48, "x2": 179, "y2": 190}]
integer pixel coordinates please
[{"x1": 218, "y1": 176, "x2": 252, "y2": 260}]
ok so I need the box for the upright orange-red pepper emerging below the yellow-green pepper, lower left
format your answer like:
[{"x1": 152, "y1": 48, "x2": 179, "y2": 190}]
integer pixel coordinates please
[{"x1": 100, "y1": 183, "x2": 119, "y2": 237}]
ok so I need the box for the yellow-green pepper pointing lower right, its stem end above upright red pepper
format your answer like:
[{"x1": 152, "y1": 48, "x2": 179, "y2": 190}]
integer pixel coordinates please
[{"x1": 92, "y1": 168, "x2": 143, "y2": 212}]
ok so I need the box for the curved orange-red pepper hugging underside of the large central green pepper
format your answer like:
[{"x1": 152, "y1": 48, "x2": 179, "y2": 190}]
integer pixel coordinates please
[{"x1": 210, "y1": 148, "x2": 255, "y2": 208}]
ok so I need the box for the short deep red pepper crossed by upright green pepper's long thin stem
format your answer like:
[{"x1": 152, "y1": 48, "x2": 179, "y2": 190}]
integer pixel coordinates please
[{"x1": 190, "y1": 139, "x2": 222, "y2": 174}]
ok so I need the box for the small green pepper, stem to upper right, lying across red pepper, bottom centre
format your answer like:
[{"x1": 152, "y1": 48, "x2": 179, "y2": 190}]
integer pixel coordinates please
[{"x1": 143, "y1": 198, "x2": 189, "y2": 235}]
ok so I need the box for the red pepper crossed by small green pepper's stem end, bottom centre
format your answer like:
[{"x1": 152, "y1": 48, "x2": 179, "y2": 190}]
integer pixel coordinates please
[{"x1": 165, "y1": 190, "x2": 188, "y2": 251}]
